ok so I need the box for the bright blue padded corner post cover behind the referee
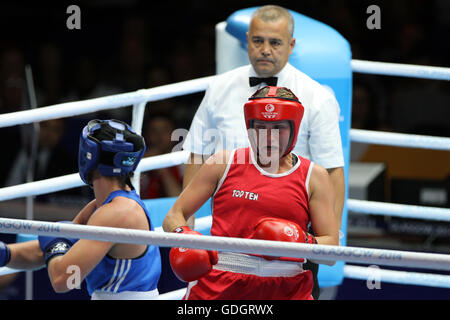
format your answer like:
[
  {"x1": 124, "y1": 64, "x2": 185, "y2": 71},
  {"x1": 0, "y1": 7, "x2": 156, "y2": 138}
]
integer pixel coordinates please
[{"x1": 225, "y1": 7, "x2": 352, "y2": 287}]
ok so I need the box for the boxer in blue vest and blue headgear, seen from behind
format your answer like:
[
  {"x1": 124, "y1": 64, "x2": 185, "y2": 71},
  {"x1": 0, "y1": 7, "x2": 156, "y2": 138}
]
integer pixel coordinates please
[{"x1": 0, "y1": 120, "x2": 161, "y2": 300}]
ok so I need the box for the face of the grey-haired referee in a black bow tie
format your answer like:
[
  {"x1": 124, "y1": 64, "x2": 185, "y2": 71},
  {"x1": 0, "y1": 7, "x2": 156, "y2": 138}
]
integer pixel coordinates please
[{"x1": 247, "y1": 17, "x2": 295, "y2": 78}]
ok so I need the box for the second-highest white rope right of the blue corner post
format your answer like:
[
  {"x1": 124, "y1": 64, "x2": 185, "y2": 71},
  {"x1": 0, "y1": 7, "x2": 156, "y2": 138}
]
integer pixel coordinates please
[{"x1": 350, "y1": 129, "x2": 450, "y2": 150}]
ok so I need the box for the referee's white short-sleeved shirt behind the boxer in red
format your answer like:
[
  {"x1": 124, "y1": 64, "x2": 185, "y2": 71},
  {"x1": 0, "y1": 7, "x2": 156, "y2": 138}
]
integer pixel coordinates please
[{"x1": 183, "y1": 63, "x2": 344, "y2": 168}]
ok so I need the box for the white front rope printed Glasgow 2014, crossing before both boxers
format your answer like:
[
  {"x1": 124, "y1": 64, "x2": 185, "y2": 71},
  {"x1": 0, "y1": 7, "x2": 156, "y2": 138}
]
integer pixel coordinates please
[{"x1": 0, "y1": 218, "x2": 450, "y2": 270}]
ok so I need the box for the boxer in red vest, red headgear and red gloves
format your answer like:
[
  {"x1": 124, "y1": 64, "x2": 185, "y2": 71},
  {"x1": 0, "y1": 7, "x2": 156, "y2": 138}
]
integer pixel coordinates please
[{"x1": 163, "y1": 87, "x2": 338, "y2": 300}]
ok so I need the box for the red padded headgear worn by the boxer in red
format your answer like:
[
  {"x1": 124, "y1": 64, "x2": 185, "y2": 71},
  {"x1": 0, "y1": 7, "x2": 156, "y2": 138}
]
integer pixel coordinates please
[{"x1": 244, "y1": 87, "x2": 305, "y2": 156}]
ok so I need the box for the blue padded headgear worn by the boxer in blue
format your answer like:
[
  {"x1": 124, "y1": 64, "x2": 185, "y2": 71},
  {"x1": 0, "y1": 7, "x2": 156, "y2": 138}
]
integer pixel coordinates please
[{"x1": 78, "y1": 120, "x2": 145, "y2": 187}]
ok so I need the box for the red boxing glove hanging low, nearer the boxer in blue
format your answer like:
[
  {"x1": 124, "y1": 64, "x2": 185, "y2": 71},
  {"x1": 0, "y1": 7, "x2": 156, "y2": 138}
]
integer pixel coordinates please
[{"x1": 169, "y1": 226, "x2": 219, "y2": 282}]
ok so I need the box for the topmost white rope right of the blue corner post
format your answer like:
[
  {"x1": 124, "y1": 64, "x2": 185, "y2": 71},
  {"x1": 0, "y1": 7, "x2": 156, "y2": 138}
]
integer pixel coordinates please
[{"x1": 350, "y1": 59, "x2": 450, "y2": 80}]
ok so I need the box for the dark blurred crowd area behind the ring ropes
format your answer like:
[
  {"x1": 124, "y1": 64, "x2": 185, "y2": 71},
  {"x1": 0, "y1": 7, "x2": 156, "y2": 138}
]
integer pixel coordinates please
[{"x1": 0, "y1": 0, "x2": 450, "y2": 201}]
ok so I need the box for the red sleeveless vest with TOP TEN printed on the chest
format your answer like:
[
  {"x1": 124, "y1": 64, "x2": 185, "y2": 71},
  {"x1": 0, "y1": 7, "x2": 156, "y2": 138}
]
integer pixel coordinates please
[{"x1": 211, "y1": 148, "x2": 312, "y2": 238}]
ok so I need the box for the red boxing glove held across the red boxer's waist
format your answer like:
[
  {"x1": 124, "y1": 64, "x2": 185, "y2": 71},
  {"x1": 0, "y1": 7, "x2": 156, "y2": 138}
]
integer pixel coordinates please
[{"x1": 252, "y1": 218, "x2": 317, "y2": 263}]
